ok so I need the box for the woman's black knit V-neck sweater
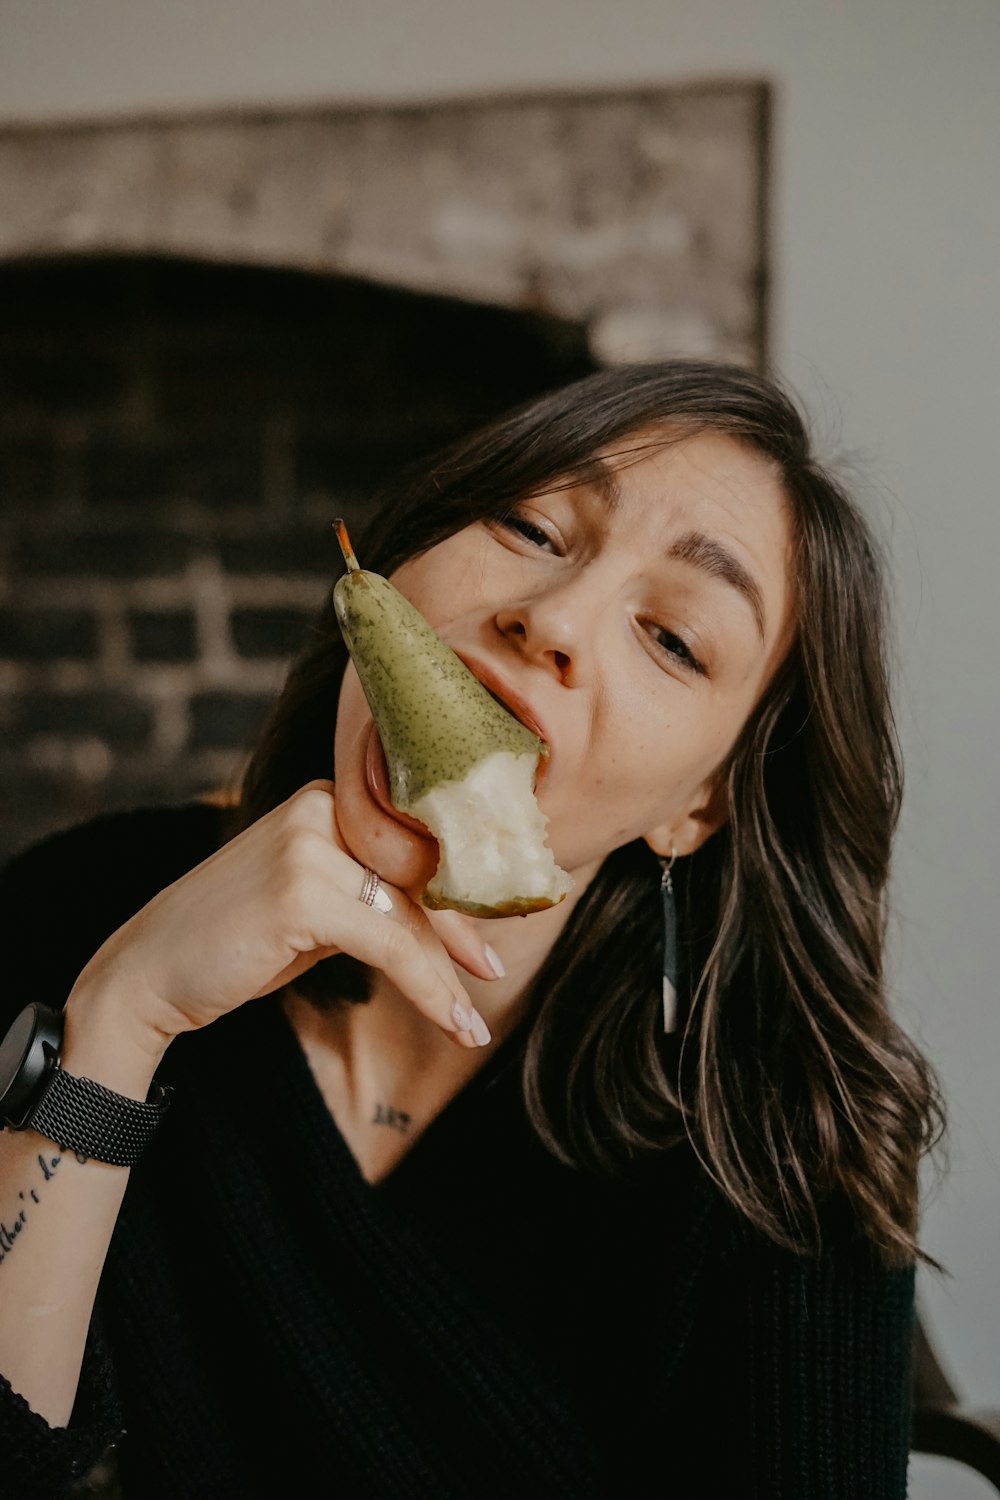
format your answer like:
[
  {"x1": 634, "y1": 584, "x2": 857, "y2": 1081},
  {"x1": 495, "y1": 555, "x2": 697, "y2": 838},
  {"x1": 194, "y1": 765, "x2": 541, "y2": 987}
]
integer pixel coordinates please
[{"x1": 0, "y1": 807, "x2": 913, "y2": 1500}]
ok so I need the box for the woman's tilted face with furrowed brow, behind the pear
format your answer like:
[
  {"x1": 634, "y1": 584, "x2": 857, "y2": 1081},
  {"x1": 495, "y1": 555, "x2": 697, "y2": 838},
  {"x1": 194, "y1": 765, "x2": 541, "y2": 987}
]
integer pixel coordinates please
[{"x1": 334, "y1": 434, "x2": 793, "y2": 890}]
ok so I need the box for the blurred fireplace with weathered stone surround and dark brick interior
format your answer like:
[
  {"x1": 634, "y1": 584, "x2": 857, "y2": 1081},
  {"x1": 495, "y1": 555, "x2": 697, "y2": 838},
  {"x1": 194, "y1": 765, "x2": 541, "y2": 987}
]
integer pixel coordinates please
[{"x1": 0, "y1": 80, "x2": 771, "y2": 858}]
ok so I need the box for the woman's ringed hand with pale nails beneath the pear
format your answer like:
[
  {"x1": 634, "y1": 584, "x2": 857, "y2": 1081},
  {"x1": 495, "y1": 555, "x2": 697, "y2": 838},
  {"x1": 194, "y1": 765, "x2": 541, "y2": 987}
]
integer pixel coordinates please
[{"x1": 67, "y1": 782, "x2": 495, "y2": 1053}]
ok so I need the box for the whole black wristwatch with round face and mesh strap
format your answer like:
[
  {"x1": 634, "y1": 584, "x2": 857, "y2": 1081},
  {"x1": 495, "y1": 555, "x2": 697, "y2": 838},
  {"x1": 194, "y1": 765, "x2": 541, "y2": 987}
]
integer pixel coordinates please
[{"x1": 0, "y1": 1001, "x2": 171, "y2": 1167}]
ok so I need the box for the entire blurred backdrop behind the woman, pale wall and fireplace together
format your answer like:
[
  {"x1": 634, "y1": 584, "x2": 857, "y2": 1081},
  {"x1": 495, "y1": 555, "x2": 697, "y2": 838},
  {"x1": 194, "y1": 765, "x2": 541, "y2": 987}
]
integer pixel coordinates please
[{"x1": 0, "y1": 0, "x2": 1000, "y2": 1500}]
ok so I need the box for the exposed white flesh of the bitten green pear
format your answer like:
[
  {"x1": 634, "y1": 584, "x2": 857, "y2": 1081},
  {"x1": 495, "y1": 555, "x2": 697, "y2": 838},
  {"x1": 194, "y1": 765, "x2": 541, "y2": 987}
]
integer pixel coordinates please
[{"x1": 412, "y1": 750, "x2": 573, "y2": 915}]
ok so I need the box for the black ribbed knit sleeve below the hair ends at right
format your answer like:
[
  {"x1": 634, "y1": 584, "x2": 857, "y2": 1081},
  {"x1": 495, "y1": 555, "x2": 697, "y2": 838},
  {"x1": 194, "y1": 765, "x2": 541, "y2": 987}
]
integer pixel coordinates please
[{"x1": 748, "y1": 1250, "x2": 915, "y2": 1500}]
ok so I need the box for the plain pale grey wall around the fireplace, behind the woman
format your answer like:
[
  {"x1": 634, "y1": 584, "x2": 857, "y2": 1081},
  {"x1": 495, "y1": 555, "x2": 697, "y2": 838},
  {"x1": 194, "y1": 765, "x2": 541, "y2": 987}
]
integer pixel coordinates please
[{"x1": 0, "y1": 0, "x2": 1000, "y2": 1404}]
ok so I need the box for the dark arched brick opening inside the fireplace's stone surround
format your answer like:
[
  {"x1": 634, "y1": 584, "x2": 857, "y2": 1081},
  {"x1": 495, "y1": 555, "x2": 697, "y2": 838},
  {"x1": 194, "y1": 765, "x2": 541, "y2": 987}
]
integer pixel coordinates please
[{"x1": 0, "y1": 257, "x2": 594, "y2": 858}]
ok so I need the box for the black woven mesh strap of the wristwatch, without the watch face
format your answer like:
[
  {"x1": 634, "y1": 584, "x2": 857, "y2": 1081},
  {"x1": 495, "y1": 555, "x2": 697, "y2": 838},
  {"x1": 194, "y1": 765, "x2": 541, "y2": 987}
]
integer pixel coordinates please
[{"x1": 25, "y1": 1067, "x2": 171, "y2": 1167}]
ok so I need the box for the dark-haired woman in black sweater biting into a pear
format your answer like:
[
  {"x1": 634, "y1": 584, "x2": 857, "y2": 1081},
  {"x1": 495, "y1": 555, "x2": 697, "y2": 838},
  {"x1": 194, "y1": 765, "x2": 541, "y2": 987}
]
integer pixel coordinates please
[{"x1": 0, "y1": 362, "x2": 936, "y2": 1500}]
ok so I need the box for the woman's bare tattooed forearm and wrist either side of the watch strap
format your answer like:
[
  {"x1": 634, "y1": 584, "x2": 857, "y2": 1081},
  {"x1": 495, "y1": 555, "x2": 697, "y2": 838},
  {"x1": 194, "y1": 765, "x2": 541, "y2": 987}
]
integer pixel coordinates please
[{"x1": 0, "y1": 995, "x2": 166, "y2": 1427}]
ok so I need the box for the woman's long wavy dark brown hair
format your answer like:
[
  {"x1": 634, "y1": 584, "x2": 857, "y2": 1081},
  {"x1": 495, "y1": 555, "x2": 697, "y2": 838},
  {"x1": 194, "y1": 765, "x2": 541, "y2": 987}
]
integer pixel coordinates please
[{"x1": 237, "y1": 360, "x2": 942, "y2": 1265}]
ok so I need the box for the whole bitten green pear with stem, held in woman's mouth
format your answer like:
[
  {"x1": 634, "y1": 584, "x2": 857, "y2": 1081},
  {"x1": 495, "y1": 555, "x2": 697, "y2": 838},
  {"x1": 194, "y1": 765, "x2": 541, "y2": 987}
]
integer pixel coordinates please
[{"x1": 333, "y1": 521, "x2": 573, "y2": 917}]
